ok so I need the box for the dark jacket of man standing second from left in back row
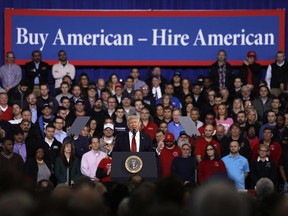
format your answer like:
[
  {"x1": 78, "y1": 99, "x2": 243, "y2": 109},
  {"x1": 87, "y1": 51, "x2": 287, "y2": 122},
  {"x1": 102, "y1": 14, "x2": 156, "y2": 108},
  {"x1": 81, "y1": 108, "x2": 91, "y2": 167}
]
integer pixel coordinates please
[{"x1": 25, "y1": 61, "x2": 49, "y2": 91}]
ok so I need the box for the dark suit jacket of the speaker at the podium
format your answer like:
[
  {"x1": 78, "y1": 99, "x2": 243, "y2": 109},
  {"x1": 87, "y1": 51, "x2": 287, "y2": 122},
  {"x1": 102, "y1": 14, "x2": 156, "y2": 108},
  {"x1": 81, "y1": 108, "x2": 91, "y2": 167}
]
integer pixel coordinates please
[{"x1": 113, "y1": 132, "x2": 153, "y2": 152}]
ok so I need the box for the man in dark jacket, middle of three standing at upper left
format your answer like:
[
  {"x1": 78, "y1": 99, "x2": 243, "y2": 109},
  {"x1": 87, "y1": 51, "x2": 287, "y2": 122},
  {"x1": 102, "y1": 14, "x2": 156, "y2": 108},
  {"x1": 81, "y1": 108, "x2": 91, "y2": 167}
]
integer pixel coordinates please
[{"x1": 25, "y1": 50, "x2": 49, "y2": 96}]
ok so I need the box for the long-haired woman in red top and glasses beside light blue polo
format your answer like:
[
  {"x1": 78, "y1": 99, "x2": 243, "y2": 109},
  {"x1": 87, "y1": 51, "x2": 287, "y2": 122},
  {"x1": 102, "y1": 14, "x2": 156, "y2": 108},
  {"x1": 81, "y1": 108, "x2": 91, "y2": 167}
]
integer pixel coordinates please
[{"x1": 198, "y1": 143, "x2": 227, "y2": 184}]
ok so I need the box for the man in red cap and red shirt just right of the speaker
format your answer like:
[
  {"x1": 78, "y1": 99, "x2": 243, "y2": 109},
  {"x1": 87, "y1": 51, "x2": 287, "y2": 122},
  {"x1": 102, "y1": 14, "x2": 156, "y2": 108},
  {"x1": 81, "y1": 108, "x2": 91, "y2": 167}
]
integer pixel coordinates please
[{"x1": 160, "y1": 132, "x2": 181, "y2": 177}]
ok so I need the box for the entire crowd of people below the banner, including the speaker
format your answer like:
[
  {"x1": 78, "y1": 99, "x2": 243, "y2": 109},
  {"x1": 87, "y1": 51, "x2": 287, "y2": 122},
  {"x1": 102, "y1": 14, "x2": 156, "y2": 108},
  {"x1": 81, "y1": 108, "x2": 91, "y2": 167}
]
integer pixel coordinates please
[{"x1": 0, "y1": 50, "x2": 288, "y2": 215}]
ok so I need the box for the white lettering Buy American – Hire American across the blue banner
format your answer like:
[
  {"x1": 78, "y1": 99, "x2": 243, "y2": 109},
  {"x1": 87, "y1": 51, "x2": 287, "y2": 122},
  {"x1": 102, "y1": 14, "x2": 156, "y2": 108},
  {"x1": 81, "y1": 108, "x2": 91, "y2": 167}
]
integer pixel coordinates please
[{"x1": 16, "y1": 27, "x2": 275, "y2": 50}]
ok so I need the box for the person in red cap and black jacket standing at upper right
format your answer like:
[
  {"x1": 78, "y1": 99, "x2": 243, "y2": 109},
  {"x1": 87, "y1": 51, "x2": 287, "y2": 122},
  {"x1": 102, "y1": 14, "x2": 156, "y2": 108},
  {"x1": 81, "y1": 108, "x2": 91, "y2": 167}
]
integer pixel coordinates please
[{"x1": 239, "y1": 51, "x2": 261, "y2": 91}]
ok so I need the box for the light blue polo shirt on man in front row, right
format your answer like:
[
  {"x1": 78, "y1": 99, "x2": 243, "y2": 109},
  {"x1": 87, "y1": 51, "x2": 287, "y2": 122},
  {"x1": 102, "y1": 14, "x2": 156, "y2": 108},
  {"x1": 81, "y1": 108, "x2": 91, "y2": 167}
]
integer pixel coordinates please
[{"x1": 222, "y1": 154, "x2": 250, "y2": 189}]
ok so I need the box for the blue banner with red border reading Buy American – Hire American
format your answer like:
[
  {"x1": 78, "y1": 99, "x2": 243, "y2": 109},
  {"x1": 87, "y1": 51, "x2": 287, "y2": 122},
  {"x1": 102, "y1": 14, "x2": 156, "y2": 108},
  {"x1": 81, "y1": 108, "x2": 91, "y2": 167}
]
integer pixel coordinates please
[{"x1": 5, "y1": 9, "x2": 285, "y2": 66}]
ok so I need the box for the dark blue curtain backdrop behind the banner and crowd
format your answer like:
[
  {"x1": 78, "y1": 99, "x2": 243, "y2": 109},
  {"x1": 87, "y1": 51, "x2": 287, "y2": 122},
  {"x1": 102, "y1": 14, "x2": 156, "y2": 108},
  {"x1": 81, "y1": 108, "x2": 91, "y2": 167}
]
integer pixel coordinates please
[{"x1": 0, "y1": 0, "x2": 288, "y2": 88}]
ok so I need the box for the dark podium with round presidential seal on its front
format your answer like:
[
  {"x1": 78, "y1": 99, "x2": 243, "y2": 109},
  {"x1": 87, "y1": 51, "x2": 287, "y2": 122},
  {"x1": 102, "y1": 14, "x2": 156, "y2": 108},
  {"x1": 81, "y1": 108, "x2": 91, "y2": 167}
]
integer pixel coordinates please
[{"x1": 110, "y1": 152, "x2": 158, "y2": 182}]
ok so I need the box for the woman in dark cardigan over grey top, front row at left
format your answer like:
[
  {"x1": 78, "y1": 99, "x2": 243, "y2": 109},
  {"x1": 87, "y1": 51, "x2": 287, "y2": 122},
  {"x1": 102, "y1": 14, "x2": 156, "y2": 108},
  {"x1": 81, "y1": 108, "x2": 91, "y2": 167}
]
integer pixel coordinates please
[{"x1": 24, "y1": 147, "x2": 52, "y2": 186}]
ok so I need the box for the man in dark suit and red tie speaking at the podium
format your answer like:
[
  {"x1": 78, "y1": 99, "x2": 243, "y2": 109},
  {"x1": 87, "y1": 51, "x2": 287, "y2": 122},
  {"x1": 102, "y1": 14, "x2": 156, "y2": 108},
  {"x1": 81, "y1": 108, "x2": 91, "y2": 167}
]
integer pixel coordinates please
[{"x1": 105, "y1": 115, "x2": 163, "y2": 154}]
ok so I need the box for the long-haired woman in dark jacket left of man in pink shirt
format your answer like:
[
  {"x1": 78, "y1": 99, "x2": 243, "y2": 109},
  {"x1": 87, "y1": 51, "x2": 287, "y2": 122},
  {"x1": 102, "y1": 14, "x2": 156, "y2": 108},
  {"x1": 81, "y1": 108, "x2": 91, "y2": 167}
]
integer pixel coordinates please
[{"x1": 55, "y1": 141, "x2": 81, "y2": 186}]
